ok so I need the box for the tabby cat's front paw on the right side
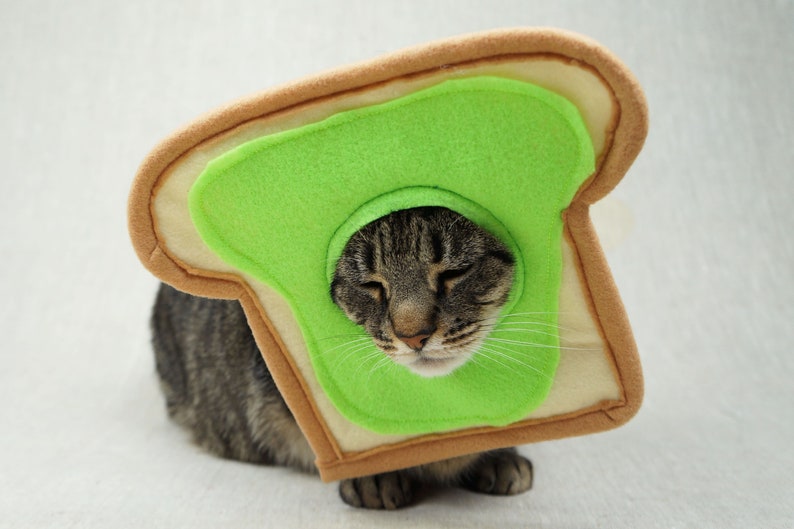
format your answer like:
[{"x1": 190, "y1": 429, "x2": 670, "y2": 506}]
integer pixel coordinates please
[{"x1": 461, "y1": 450, "x2": 532, "y2": 495}]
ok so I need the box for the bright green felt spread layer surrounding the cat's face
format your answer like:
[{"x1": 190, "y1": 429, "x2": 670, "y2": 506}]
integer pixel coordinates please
[{"x1": 189, "y1": 77, "x2": 594, "y2": 434}]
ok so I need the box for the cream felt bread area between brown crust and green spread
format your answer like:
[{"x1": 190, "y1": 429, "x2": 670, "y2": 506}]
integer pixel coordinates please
[{"x1": 154, "y1": 57, "x2": 622, "y2": 452}]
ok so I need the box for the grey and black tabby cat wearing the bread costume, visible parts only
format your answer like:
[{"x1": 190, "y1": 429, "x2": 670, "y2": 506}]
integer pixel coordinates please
[{"x1": 152, "y1": 207, "x2": 532, "y2": 509}]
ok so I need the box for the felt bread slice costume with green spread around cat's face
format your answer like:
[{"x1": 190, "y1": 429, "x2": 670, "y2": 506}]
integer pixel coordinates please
[{"x1": 129, "y1": 29, "x2": 647, "y2": 481}]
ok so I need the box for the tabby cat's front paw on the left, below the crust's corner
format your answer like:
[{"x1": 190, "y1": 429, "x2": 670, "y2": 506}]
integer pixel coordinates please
[{"x1": 339, "y1": 472, "x2": 414, "y2": 510}]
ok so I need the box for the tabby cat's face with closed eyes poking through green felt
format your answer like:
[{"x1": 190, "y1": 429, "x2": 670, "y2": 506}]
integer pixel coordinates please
[{"x1": 331, "y1": 207, "x2": 514, "y2": 377}]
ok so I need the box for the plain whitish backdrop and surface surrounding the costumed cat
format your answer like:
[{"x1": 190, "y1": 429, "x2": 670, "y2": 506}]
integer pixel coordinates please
[{"x1": 0, "y1": 0, "x2": 794, "y2": 528}]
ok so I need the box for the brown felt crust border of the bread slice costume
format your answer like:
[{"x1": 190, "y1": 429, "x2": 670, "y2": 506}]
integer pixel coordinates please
[{"x1": 129, "y1": 29, "x2": 647, "y2": 481}]
